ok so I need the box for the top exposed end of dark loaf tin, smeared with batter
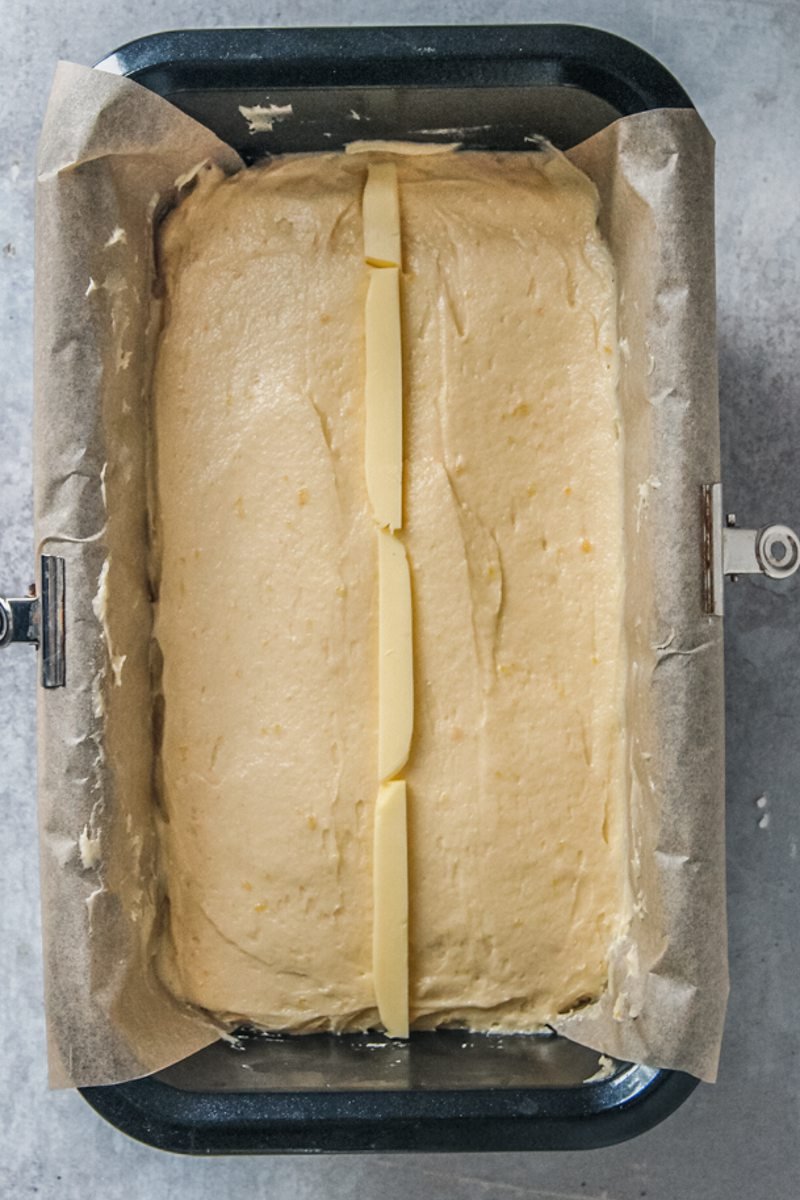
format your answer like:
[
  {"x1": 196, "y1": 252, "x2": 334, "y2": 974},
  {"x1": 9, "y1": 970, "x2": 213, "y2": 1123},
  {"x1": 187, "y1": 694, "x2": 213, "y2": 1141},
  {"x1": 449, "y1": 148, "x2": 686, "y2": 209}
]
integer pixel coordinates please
[{"x1": 98, "y1": 25, "x2": 692, "y2": 162}]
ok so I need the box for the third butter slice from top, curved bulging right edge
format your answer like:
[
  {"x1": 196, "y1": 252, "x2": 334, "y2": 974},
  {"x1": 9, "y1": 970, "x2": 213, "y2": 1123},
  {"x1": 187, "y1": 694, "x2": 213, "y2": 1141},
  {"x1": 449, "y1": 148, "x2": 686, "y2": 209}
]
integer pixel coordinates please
[{"x1": 378, "y1": 529, "x2": 414, "y2": 780}]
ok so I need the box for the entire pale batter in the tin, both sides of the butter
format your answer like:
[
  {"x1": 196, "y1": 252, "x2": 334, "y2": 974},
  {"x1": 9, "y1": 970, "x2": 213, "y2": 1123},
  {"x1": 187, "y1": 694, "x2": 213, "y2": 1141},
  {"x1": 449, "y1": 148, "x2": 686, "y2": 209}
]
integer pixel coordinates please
[{"x1": 148, "y1": 152, "x2": 625, "y2": 1030}]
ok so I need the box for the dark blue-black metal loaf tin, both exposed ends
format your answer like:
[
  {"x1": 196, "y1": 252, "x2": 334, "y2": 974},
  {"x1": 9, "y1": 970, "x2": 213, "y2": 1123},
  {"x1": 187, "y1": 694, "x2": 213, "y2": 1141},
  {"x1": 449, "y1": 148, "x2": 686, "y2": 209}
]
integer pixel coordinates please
[{"x1": 77, "y1": 25, "x2": 696, "y2": 1154}]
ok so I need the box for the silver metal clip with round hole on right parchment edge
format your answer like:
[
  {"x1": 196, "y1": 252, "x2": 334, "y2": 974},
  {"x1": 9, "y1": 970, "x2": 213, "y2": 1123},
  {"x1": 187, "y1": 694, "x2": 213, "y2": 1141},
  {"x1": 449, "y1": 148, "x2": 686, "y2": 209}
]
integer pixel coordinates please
[{"x1": 703, "y1": 484, "x2": 800, "y2": 617}]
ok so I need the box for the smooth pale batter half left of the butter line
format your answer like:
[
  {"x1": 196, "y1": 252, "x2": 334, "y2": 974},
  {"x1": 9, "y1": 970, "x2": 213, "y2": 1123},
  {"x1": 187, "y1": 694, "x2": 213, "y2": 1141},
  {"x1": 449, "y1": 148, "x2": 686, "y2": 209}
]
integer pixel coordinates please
[{"x1": 154, "y1": 158, "x2": 377, "y2": 1028}]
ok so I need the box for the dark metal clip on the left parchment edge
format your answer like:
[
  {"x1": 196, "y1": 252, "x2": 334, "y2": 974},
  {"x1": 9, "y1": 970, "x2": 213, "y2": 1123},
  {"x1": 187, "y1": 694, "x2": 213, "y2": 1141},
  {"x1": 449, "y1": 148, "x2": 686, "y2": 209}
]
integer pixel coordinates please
[{"x1": 0, "y1": 554, "x2": 66, "y2": 688}]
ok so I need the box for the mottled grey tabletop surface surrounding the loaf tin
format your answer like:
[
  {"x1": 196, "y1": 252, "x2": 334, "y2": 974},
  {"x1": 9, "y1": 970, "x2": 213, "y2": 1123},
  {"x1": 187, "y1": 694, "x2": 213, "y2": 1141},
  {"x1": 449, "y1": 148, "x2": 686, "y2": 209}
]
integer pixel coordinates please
[{"x1": 0, "y1": 0, "x2": 800, "y2": 1200}]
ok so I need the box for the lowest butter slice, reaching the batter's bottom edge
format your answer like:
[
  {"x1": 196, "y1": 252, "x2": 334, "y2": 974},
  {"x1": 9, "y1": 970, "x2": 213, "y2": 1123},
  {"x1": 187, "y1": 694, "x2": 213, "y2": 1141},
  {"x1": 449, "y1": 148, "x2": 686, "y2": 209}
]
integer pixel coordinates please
[{"x1": 372, "y1": 780, "x2": 408, "y2": 1038}]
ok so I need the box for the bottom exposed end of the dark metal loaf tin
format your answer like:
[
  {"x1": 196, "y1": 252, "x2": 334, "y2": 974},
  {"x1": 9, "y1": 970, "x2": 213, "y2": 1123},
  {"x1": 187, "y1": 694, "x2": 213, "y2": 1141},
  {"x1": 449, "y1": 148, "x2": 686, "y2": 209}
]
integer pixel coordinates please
[{"x1": 83, "y1": 1030, "x2": 696, "y2": 1154}]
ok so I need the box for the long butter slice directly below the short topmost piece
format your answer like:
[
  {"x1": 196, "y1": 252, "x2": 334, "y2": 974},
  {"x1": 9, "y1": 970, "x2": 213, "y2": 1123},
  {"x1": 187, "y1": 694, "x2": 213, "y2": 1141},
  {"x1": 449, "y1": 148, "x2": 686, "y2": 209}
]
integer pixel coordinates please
[{"x1": 365, "y1": 266, "x2": 403, "y2": 529}]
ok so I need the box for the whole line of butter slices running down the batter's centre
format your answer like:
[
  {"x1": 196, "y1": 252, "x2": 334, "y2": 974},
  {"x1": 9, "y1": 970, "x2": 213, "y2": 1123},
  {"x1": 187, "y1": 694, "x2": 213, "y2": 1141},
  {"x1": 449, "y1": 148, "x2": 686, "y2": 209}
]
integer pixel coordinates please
[{"x1": 362, "y1": 163, "x2": 414, "y2": 1038}]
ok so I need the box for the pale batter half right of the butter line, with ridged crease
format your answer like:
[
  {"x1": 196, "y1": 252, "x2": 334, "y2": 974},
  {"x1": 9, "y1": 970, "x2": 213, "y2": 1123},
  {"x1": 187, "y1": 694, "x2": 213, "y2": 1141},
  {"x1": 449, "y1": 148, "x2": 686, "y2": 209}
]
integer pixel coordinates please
[{"x1": 402, "y1": 155, "x2": 625, "y2": 1030}]
